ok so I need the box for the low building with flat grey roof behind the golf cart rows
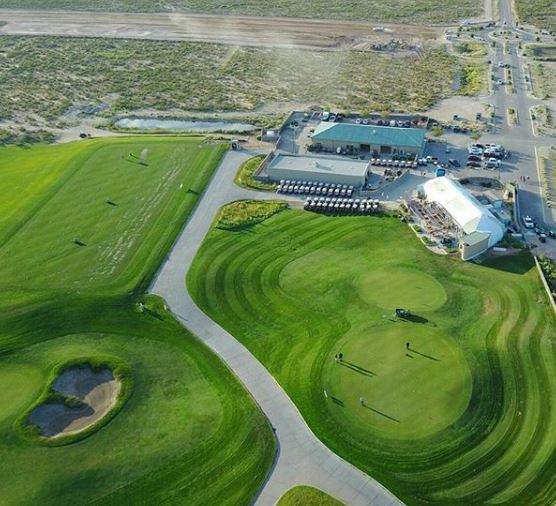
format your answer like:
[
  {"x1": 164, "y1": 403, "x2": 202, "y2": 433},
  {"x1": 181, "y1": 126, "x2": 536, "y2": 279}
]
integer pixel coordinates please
[{"x1": 265, "y1": 154, "x2": 370, "y2": 187}]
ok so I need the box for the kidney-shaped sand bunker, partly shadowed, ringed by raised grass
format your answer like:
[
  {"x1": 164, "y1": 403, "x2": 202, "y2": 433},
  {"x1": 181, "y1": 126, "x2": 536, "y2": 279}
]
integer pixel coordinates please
[{"x1": 28, "y1": 367, "x2": 121, "y2": 437}]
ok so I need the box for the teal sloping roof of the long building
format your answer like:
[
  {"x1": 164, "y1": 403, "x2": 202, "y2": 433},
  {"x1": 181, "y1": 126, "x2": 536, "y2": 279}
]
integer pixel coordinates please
[{"x1": 311, "y1": 121, "x2": 425, "y2": 148}]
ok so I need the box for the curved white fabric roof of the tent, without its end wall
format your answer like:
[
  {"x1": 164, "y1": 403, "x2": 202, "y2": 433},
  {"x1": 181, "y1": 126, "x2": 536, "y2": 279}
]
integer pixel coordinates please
[{"x1": 423, "y1": 176, "x2": 505, "y2": 248}]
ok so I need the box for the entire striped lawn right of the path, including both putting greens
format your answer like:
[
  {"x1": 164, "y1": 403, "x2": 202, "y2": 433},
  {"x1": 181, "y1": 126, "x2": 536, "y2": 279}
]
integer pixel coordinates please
[{"x1": 187, "y1": 210, "x2": 556, "y2": 506}]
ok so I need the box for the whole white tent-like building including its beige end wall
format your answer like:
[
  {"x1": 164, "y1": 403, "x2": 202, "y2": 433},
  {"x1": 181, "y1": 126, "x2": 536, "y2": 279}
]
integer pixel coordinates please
[{"x1": 421, "y1": 176, "x2": 505, "y2": 260}]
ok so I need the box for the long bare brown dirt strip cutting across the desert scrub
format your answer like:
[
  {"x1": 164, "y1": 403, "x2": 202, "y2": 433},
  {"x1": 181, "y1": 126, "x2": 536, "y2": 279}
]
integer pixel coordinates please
[{"x1": 0, "y1": 9, "x2": 443, "y2": 50}]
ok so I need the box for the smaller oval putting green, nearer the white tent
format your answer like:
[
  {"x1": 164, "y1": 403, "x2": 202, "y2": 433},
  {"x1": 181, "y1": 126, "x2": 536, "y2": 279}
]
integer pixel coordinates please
[{"x1": 357, "y1": 268, "x2": 447, "y2": 311}]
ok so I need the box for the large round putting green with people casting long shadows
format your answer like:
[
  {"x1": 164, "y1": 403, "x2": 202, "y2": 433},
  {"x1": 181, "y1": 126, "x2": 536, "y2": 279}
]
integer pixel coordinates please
[{"x1": 323, "y1": 322, "x2": 472, "y2": 439}]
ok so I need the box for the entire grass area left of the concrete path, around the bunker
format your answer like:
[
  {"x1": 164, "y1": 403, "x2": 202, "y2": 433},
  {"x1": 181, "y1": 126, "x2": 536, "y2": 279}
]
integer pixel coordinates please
[{"x1": 0, "y1": 137, "x2": 275, "y2": 505}]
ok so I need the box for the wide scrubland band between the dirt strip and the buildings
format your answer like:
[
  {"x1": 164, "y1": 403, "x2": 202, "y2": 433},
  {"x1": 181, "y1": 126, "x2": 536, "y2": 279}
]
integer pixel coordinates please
[{"x1": 0, "y1": 37, "x2": 458, "y2": 126}]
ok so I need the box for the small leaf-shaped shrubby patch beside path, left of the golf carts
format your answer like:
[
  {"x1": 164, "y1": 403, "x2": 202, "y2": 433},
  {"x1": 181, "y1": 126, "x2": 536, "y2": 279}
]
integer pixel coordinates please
[{"x1": 216, "y1": 200, "x2": 288, "y2": 230}]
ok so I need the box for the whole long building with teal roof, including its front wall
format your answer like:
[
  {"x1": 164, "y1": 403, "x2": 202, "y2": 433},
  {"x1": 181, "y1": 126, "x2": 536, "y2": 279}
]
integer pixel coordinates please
[{"x1": 311, "y1": 121, "x2": 425, "y2": 156}]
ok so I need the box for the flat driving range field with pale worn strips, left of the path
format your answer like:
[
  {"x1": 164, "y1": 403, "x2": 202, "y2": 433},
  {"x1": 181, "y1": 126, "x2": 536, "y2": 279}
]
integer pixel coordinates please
[{"x1": 0, "y1": 137, "x2": 223, "y2": 290}]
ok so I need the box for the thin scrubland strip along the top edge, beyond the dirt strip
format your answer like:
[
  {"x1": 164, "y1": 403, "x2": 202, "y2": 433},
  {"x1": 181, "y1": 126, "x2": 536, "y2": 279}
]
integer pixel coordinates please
[{"x1": 0, "y1": 0, "x2": 482, "y2": 23}]
